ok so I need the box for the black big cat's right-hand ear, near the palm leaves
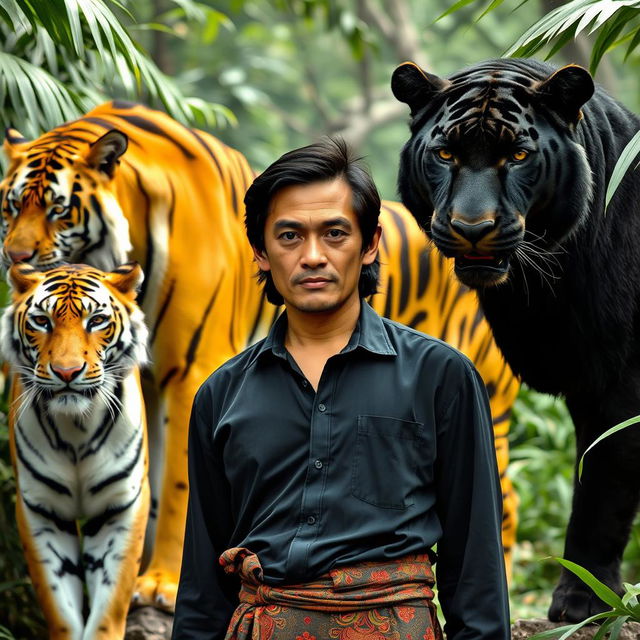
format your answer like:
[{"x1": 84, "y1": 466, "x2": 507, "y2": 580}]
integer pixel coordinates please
[{"x1": 536, "y1": 64, "x2": 595, "y2": 124}]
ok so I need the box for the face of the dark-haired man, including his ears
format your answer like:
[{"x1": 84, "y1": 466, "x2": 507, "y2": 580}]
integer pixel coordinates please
[{"x1": 254, "y1": 178, "x2": 380, "y2": 313}]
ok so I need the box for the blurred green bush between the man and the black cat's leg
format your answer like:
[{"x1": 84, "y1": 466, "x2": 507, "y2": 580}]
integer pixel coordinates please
[{"x1": 509, "y1": 388, "x2": 640, "y2": 620}]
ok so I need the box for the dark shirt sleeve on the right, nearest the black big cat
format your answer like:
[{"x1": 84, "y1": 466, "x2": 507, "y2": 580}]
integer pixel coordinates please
[{"x1": 436, "y1": 361, "x2": 511, "y2": 640}]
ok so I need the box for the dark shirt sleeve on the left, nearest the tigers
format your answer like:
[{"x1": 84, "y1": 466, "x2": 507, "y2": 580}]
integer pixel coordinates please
[{"x1": 171, "y1": 388, "x2": 238, "y2": 640}]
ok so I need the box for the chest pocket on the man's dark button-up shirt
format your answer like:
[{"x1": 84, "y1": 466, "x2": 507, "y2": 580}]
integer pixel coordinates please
[{"x1": 351, "y1": 416, "x2": 424, "y2": 509}]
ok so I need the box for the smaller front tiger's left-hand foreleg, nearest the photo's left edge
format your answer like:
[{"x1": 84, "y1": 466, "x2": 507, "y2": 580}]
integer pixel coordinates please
[{"x1": 16, "y1": 494, "x2": 84, "y2": 640}]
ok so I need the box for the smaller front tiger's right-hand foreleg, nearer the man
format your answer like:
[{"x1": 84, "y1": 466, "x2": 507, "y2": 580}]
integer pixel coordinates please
[{"x1": 82, "y1": 479, "x2": 149, "y2": 640}]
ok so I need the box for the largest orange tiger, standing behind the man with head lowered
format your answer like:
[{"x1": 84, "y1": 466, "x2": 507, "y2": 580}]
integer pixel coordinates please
[{"x1": 0, "y1": 101, "x2": 518, "y2": 609}]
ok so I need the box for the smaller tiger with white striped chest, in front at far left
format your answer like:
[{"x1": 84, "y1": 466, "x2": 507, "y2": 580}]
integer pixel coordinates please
[{"x1": 0, "y1": 264, "x2": 149, "y2": 640}]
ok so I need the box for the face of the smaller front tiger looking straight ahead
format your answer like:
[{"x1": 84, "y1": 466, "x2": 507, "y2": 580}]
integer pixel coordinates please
[{"x1": 0, "y1": 263, "x2": 147, "y2": 415}]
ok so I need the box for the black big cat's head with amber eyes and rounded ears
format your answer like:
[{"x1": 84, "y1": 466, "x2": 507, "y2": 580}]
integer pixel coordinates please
[{"x1": 392, "y1": 60, "x2": 593, "y2": 287}]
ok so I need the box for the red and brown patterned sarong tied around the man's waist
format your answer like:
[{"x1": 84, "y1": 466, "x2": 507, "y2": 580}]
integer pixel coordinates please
[{"x1": 220, "y1": 547, "x2": 442, "y2": 640}]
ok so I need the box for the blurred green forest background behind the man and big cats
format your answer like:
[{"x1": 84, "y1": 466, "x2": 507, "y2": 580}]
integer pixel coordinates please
[{"x1": 0, "y1": 0, "x2": 640, "y2": 640}]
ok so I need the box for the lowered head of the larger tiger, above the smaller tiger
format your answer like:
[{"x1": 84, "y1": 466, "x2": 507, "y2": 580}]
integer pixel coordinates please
[{"x1": 0, "y1": 129, "x2": 131, "y2": 270}]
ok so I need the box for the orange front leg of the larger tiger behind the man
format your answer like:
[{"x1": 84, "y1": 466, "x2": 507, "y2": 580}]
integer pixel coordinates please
[{"x1": 134, "y1": 376, "x2": 192, "y2": 611}]
